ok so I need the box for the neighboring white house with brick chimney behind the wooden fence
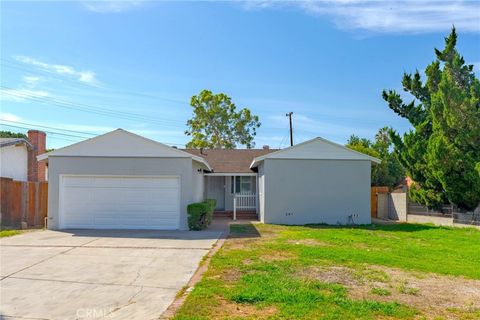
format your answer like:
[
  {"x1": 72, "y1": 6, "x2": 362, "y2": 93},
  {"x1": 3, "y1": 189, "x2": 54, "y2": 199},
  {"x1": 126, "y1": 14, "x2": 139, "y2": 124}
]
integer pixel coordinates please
[{"x1": 0, "y1": 130, "x2": 46, "y2": 181}]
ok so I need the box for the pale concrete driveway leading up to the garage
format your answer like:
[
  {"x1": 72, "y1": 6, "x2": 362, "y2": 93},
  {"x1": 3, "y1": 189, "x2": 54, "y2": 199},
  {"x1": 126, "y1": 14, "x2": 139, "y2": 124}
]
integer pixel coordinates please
[{"x1": 0, "y1": 230, "x2": 221, "y2": 319}]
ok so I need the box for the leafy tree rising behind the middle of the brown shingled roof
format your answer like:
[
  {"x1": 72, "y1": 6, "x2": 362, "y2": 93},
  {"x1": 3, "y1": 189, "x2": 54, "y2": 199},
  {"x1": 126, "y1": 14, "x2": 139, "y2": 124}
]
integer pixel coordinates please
[{"x1": 185, "y1": 90, "x2": 260, "y2": 149}]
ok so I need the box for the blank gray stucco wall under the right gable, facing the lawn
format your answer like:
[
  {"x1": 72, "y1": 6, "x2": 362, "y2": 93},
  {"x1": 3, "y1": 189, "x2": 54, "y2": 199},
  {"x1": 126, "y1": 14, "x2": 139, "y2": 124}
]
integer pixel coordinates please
[{"x1": 263, "y1": 159, "x2": 371, "y2": 225}]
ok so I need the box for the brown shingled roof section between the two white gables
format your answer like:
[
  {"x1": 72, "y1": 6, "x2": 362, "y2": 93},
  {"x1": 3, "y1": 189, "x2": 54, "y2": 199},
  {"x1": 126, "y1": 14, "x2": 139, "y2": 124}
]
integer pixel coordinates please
[{"x1": 184, "y1": 149, "x2": 278, "y2": 173}]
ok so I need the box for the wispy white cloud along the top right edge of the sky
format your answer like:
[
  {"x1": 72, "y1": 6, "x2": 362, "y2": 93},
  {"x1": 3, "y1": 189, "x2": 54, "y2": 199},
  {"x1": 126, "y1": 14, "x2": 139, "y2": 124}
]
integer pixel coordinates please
[{"x1": 245, "y1": 0, "x2": 480, "y2": 33}]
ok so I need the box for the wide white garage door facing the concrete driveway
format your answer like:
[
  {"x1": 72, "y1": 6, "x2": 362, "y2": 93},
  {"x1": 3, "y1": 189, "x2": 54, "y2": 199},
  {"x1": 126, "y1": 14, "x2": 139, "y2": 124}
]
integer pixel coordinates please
[{"x1": 60, "y1": 176, "x2": 180, "y2": 230}]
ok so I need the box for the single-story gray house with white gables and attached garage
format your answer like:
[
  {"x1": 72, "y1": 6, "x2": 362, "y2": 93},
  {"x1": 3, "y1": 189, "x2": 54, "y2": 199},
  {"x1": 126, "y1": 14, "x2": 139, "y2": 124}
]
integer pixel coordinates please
[{"x1": 38, "y1": 129, "x2": 379, "y2": 230}]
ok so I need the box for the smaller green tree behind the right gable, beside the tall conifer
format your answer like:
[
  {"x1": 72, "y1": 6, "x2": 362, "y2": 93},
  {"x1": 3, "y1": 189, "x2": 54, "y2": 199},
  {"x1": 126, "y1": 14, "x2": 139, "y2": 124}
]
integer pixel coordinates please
[{"x1": 347, "y1": 127, "x2": 405, "y2": 188}]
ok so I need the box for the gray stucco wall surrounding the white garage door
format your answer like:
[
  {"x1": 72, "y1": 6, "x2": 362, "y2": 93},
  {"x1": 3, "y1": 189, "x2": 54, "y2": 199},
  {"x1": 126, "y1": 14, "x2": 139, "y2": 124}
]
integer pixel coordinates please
[{"x1": 48, "y1": 156, "x2": 196, "y2": 230}]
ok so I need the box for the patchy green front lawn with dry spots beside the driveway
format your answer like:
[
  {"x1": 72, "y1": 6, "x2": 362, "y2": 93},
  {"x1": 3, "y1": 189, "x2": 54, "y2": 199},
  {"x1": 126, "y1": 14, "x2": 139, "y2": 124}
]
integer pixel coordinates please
[{"x1": 175, "y1": 224, "x2": 480, "y2": 319}]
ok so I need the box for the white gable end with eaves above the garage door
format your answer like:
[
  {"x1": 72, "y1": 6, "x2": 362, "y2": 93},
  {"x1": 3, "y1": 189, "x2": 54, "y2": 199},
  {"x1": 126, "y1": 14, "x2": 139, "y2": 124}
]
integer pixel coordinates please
[{"x1": 37, "y1": 129, "x2": 212, "y2": 170}]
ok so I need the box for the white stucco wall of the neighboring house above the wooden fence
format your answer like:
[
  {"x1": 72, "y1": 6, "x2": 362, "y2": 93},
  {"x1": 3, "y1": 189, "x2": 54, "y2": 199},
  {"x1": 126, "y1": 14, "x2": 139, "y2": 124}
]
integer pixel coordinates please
[{"x1": 0, "y1": 144, "x2": 28, "y2": 181}]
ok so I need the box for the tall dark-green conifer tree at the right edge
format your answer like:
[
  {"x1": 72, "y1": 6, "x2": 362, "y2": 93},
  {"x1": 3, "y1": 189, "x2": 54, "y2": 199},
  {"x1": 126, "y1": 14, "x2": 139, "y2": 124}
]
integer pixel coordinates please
[{"x1": 383, "y1": 28, "x2": 480, "y2": 210}]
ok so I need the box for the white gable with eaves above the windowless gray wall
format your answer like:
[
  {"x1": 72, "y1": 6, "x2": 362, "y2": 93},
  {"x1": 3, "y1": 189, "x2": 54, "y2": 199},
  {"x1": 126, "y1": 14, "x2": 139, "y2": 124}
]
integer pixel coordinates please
[{"x1": 250, "y1": 137, "x2": 381, "y2": 168}]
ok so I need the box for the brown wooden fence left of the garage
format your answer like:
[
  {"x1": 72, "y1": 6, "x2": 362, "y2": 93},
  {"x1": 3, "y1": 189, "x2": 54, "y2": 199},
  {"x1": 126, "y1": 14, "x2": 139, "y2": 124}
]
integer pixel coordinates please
[{"x1": 0, "y1": 178, "x2": 48, "y2": 228}]
